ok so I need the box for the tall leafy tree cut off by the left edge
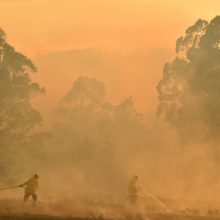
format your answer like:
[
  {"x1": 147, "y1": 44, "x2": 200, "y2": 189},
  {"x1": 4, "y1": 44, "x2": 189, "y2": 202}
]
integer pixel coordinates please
[{"x1": 0, "y1": 29, "x2": 45, "y2": 179}]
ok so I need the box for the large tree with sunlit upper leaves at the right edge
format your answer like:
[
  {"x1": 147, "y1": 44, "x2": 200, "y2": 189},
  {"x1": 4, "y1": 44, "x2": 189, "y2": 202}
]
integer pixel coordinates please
[{"x1": 157, "y1": 16, "x2": 220, "y2": 141}]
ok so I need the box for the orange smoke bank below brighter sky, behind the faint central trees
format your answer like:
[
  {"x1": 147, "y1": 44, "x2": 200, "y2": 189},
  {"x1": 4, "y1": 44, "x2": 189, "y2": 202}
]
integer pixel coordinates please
[{"x1": 33, "y1": 48, "x2": 171, "y2": 120}]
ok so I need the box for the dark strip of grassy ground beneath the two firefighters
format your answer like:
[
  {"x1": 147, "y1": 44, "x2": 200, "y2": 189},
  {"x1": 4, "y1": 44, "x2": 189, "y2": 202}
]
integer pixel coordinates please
[{"x1": 0, "y1": 200, "x2": 220, "y2": 220}]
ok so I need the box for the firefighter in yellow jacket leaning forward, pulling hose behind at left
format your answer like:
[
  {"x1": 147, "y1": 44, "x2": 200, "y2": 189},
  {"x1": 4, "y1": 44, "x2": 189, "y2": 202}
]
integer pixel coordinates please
[{"x1": 19, "y1": 173, "x2": 40, "y2": 202}]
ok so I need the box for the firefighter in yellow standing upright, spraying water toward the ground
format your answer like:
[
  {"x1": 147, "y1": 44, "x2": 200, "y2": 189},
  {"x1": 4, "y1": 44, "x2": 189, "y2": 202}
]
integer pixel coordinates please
[{"x1": 128, "y1": 175, "x2": 141, "y2": 205}]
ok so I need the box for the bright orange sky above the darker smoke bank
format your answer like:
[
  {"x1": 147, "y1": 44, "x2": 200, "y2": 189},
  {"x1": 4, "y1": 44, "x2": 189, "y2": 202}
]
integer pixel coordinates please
[{"x1": 0, "y1": 0, "x2": 219, "y2": 56}]
